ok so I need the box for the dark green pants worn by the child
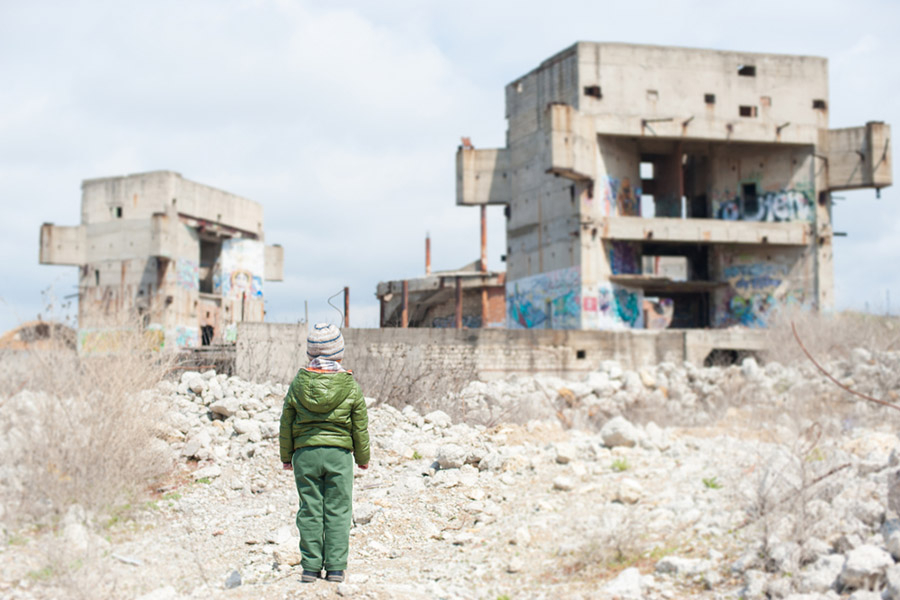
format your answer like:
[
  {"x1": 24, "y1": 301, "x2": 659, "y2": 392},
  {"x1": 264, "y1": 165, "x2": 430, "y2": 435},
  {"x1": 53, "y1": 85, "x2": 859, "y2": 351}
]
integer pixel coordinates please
[{"x1": 291, "y1": 446, "x2": 353, "y2": 571}]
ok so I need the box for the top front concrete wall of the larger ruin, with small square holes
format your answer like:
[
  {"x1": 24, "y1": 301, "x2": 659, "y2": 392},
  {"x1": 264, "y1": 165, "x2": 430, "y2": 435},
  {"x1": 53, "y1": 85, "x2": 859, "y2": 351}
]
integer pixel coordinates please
[{"x1": 570, "y1": 42, "x2": 828, "y2": 144}]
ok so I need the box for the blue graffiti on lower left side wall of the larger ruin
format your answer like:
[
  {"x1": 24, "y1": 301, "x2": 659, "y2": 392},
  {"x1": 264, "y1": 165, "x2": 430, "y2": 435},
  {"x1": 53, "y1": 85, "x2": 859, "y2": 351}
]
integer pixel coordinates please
[{"x1": 506, "y1": 267, "x2": 581, "y2": 329}]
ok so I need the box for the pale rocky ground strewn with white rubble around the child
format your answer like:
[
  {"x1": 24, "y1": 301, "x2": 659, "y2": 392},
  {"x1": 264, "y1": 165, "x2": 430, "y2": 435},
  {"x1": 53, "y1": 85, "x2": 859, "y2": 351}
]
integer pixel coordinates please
[{"x1": 0, "y1": 349, "x2": 900, "y2": 600}]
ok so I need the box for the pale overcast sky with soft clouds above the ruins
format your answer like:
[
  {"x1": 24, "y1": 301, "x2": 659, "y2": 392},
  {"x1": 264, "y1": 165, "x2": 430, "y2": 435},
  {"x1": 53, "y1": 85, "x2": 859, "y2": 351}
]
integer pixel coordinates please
[{"x1": 0, "y1": 0, "x2": 900, "y2": 332}]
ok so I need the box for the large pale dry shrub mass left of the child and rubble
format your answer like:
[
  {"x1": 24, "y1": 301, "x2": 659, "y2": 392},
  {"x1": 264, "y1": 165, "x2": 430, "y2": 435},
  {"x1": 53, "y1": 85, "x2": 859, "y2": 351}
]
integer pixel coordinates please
[{"x1": 0, "y1": 316, "x2": 173, "y2": 525}]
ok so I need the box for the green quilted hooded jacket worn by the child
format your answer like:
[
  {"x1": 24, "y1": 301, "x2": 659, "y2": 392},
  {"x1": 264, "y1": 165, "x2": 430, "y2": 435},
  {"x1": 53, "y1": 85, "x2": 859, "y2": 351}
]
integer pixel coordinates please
[{"x1": 278, "y1": 369, "x2": 369, "y2": 465}]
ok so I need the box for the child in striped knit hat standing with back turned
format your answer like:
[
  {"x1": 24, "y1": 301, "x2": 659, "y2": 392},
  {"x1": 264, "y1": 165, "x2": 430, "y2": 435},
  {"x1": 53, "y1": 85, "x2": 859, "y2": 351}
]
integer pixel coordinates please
[{"x1": 279, "y1": 323, "x2": 369, "y2": 583}]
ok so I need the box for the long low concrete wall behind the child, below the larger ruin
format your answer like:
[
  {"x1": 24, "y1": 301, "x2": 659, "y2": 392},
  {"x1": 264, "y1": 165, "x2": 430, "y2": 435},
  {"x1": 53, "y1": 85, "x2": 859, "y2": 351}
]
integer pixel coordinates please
[{"x1": 235, "y1": 323, "x2": 765, "y2": 386}]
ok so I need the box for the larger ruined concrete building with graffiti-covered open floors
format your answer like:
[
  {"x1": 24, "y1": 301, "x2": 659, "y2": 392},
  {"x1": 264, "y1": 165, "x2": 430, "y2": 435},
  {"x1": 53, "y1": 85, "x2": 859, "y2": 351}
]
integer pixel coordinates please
[{"x1": 457, "y1": 42, "x2": 891, "y2": 329}]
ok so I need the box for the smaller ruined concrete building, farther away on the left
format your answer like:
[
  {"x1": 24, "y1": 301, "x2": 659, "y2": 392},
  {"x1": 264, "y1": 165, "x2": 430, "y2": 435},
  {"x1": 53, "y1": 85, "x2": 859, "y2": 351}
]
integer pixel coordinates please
[{"x1": 40, "y1": 171, "x2": 283, "y2": 350}]
